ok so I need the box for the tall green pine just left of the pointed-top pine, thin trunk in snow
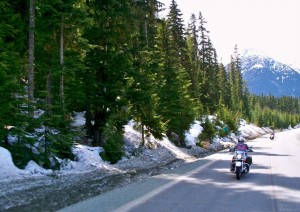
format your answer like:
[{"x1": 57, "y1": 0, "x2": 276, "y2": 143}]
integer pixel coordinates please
[{"x1": 127, "y1": 0, "x2": 165, "y2": 144}]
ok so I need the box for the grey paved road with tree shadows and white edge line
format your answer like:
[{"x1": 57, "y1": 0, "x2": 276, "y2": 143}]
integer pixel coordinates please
[{"x1": 61, "y1": 129, "x2": 300, "y2": 212}]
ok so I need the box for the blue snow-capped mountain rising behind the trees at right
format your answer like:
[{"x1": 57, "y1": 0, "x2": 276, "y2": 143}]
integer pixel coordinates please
[{"x1": 241, "y1": 52, "x2": 300, "y2": 97}]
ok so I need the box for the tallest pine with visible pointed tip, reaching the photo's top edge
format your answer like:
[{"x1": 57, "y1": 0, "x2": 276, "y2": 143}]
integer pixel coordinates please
[{"x1": 159, "y1": 0, "x2": 196, "y2": 146}]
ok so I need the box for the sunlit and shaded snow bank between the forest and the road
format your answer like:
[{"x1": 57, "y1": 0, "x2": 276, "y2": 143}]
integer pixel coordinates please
[{"x1": 0, "y1": 117, "x2": 271, "y2": 182}]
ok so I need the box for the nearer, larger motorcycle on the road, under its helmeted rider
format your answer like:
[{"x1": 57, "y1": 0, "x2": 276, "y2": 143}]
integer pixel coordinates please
[{"x1": 230, "y1": 149, "x2": 253, "y2": 180}]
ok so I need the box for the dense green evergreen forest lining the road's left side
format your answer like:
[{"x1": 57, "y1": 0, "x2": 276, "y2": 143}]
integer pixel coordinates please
[{"x1": 0, "y1": 0, "x2": 300, "y2": 169}]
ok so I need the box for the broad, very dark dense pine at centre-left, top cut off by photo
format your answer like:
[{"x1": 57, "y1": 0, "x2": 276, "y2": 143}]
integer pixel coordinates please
[{"x1": 84, "y1": 0, "x2": 135, "y2": 146}]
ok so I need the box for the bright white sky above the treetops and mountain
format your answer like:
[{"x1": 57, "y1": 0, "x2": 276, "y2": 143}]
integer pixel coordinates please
[{"x1": 160, "y1": 0, "x2": 300, "y2": 68}]
